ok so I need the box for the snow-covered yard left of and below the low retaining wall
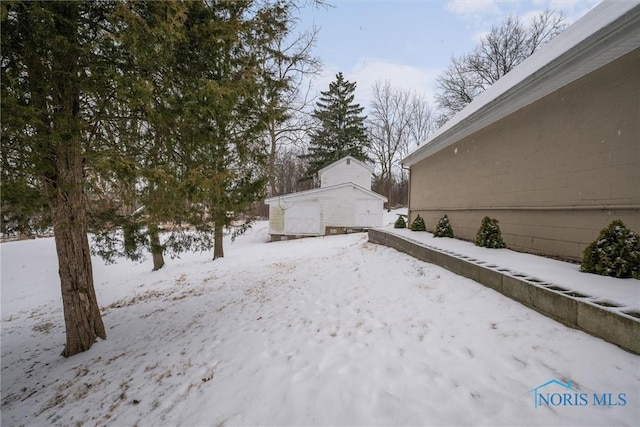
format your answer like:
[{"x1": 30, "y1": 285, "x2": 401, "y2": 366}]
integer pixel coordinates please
[{"x1": 0, "y1": 216, "x2": 640, "y2": 426}]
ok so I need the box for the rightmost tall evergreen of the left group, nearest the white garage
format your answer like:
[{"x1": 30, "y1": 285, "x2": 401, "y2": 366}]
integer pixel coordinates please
[{"x1": 174, "y1": 0, "x2": 291, "y2": 259}]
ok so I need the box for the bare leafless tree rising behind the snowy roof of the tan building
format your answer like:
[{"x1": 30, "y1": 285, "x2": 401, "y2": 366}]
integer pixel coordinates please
[{"x1": 436, "y1": 9, "x2": 567, "y2": 124}]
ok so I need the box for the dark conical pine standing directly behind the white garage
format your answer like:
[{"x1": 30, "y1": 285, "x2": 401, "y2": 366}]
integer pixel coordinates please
[{"x1": 304, "y1": 73, "x2": 369, "y2": 176}]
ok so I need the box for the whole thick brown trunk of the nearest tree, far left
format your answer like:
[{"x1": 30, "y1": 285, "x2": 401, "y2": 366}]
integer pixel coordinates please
[{"x1": 42, "y1": 2, "x2": 107, "y2": 357}]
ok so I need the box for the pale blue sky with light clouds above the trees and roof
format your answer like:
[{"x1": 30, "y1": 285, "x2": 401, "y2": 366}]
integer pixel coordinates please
[{"x1": 298, "y1": 0, "x2": 600, "y2": 107}]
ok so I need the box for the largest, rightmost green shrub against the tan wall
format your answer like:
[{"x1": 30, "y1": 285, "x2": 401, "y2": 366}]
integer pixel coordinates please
[{"x1": 580, "y1": 220, "x2": 640, "y2": 279}]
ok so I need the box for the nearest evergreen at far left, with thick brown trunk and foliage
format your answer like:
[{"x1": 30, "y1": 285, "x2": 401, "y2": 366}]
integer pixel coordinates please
[{"x1": 0, "y1": 1, "x2": 115, "y2": 356}]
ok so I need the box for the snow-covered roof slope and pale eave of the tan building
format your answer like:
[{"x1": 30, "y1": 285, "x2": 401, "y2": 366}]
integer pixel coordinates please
[{"x1": 402, "y1": 0, "x2": 640, "y2": 167}]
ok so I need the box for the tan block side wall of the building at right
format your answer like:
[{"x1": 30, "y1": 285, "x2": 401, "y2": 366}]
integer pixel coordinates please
[{"x1": 409, "y1": 49, "x2": 640, "y2": 260}]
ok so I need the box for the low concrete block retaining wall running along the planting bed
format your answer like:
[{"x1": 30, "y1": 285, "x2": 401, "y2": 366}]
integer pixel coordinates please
[{"x1": 369, "y1": 229, "x2": 640, "y2": 354}]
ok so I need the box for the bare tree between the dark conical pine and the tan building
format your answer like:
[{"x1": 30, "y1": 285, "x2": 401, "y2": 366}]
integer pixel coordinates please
[{"x1": 367, "y1": 81, "x2": 433, "y2": 205}]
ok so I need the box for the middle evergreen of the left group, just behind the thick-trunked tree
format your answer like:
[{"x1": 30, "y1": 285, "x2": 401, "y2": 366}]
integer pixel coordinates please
[{"x1": 89, "y1": 1, "x2": 188, "y2": 270}]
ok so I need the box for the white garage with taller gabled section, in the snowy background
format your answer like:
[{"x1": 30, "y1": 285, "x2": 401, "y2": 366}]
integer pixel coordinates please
[{"x1": 265, "y1": 156, "x2": 387, "y2": 240}]
